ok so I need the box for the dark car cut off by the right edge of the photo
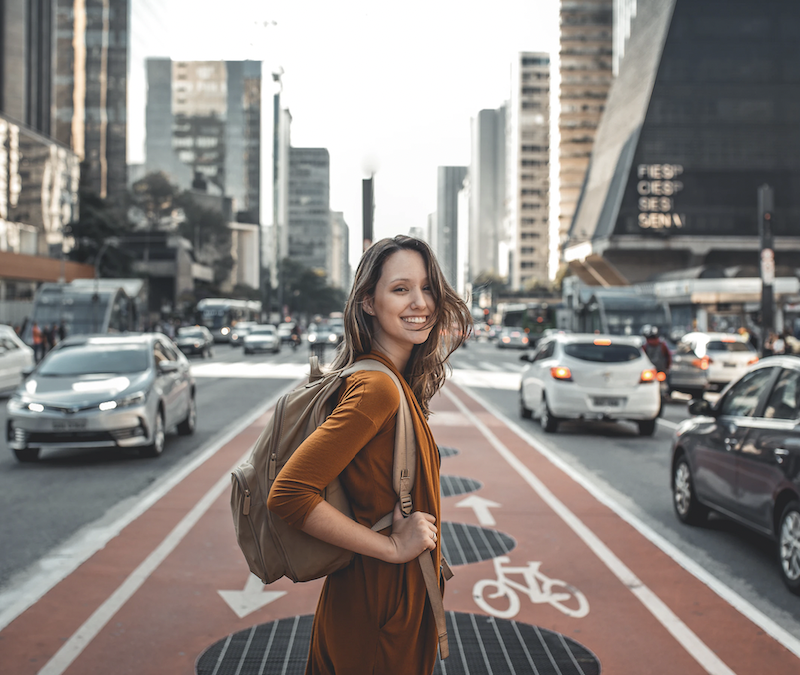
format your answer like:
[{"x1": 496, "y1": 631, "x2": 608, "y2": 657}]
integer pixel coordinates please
[{"x1": 671, "y1": 356, "x2": 800, "y2": 594}]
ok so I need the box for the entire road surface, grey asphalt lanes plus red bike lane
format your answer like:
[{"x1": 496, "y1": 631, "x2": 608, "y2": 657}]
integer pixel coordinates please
[{"x1": 0, "y1": 342, "x2": 800, "y2": 675}]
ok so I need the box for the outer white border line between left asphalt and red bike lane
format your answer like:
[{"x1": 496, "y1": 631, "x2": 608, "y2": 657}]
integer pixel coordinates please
[{"x1": 0, "y1": 381, "x2": 298, "y2": 631}]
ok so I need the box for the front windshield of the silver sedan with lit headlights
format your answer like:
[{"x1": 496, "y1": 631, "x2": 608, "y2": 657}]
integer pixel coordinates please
[{"x1": 37, "y1": 344, "x2": 149, "y2": 377}]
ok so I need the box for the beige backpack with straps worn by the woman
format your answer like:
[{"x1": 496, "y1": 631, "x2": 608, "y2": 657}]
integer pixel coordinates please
[{"x1": 231, "y1": 356, "x2": 452, "y2": 658}]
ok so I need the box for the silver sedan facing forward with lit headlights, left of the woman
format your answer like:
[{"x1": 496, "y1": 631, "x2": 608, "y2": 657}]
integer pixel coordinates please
[{"x1": 7, "y1": 333, "x2": 197, "y2": 462}]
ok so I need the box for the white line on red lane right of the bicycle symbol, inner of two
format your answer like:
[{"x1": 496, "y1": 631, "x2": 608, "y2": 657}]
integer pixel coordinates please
[{"x1": 442, "y1": 389, "x2": 734, "y2": 675}]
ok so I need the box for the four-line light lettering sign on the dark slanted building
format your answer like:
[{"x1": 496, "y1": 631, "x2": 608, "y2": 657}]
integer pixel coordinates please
[{"x1": 636, "y1": 164, "x2": 686, "y2": 230}]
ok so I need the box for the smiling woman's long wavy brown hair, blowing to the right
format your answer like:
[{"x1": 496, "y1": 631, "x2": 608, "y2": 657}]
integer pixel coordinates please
[{"x1": 332, "y1": 235, "x2": 472, "y2": 417}]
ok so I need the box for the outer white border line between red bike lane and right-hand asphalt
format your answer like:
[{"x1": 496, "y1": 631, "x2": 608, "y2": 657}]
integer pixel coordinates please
[{"x1": 450, "y1": 382, "x2": 800, "y2": 657}]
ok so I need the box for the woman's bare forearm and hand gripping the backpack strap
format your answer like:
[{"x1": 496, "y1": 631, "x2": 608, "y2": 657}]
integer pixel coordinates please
[{"x1": 303, "y1": 501, "x2": 437, "y2": 563}]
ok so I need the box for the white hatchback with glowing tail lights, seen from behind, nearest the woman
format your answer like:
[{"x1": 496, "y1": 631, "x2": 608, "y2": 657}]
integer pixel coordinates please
[{"x1": 520, "y1": 334, "x2": 661, "y2": 436}]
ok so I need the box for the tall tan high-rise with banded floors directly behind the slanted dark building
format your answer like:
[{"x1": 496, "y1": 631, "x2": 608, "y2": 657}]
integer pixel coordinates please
[{"x1": 558, "y1": 0, "x2": 616, "y2": 247}]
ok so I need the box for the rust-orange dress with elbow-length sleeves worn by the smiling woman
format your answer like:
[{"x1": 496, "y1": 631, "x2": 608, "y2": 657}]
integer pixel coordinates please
[{"x1": 268, "y1": 352, "x2": 443, "y2": 675}]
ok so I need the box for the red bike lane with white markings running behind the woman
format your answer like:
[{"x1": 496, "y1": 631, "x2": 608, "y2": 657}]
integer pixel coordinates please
[{"x1": 0, "y1": 384, "x2": 800, "y2": 675}]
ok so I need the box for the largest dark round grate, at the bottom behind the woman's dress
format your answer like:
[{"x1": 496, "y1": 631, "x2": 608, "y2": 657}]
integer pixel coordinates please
[{"x1": 195, "y1": 612, "x2": 600, "y2": 675}]
